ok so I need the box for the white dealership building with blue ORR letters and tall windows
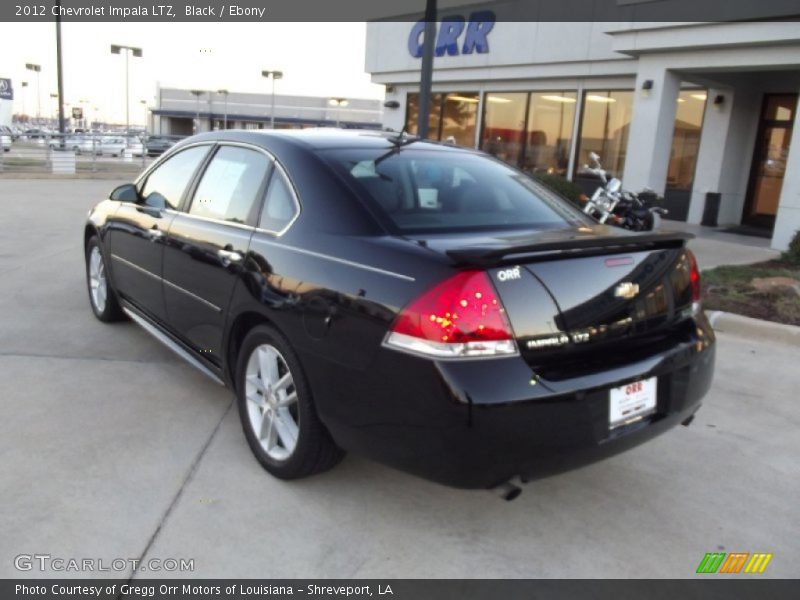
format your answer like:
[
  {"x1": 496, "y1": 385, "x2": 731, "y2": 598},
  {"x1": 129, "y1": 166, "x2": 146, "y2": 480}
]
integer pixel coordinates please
[{"x1": 366, "y1": 18, "x2": 800, "y2": 249}]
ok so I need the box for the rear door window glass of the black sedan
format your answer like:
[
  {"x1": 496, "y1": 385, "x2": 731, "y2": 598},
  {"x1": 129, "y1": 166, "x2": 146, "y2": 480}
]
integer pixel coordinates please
[{"x1": 189, "y1": 146, "x2": 271, "y2": 223}]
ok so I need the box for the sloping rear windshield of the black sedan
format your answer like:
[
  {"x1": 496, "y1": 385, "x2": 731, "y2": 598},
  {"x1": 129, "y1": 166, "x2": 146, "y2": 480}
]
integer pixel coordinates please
[{"x1": 322, "y1": 147, "x2": 582, "y2": 233}]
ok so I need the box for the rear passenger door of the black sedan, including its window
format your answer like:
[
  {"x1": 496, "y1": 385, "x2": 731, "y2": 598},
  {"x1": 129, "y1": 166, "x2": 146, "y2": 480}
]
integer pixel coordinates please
[{"x1": 164, "y1": 143, "x2": 272, "y2": 364}]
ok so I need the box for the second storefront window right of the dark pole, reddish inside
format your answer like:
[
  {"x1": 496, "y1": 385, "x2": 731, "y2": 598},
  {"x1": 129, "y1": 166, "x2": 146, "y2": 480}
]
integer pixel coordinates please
[{"x1": 481, "y1": 92, "x2": 528, "y2": 165}]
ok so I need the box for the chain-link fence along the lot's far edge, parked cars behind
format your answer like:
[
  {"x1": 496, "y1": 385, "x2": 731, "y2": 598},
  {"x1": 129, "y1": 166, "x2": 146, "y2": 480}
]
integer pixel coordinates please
[{"x1": 0, "y1": 132, "x2": 178, "y2": 178}]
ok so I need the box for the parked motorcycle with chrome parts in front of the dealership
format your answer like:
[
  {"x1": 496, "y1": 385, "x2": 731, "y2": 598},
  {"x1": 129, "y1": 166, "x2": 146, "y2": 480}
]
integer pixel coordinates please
[{"x1": 581, "y1": 152, "x2": 668, "y2": 231}]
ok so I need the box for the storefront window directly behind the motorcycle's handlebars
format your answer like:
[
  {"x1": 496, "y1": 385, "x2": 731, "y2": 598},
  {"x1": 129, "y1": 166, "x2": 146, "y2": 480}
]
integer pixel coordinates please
[{"x1": 575, "y1": 90, "x2": 633, "y2": 178}]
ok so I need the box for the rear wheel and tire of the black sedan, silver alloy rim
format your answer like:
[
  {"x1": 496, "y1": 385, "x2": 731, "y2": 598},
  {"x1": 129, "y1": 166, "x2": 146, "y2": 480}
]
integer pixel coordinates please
[{"x1": 236, "y1": 325, "x2": 344, "y2": 479}]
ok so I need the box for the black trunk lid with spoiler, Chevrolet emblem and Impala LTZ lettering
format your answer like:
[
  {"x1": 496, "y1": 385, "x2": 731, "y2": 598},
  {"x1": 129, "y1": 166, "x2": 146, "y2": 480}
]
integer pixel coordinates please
[{"x1": 416, "y1": 226, "x2": 692, "y2": 376}]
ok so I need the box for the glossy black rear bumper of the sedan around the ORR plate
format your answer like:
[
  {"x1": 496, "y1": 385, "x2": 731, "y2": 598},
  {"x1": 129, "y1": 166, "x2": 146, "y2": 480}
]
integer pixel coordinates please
[{"x1": 312, "y1": 315, "x2": 715, "y2": 488}]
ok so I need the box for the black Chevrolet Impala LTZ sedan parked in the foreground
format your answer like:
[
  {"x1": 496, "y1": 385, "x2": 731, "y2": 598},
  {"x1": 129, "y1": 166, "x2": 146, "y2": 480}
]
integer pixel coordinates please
[{"x1": 84, "y1": 130, "x2": 715, "y2": 490}]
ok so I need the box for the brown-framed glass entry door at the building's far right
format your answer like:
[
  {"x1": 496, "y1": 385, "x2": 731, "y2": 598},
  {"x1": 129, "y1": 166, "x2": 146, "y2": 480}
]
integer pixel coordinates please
[{"x1": 742, "y1": 94, "x2": 797, "y2": 230}]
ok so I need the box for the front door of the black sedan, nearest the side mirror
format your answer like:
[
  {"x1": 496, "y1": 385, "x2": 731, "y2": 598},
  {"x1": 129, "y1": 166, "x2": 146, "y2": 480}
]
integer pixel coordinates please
[{"x1": 108, "y1": 145, "x2": 211, "y2": 321}]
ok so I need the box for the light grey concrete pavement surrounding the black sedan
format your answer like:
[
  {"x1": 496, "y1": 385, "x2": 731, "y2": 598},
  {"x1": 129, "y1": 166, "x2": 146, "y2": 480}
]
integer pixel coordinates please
[{"x1": 0, "y1": 180, "x2": 800, "y2": 578}]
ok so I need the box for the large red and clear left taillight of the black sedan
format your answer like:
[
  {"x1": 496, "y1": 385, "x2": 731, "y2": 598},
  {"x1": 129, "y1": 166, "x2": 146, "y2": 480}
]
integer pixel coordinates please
[{"x1": 385, "y1": 271, "x2": 517, "y2": 358}]
